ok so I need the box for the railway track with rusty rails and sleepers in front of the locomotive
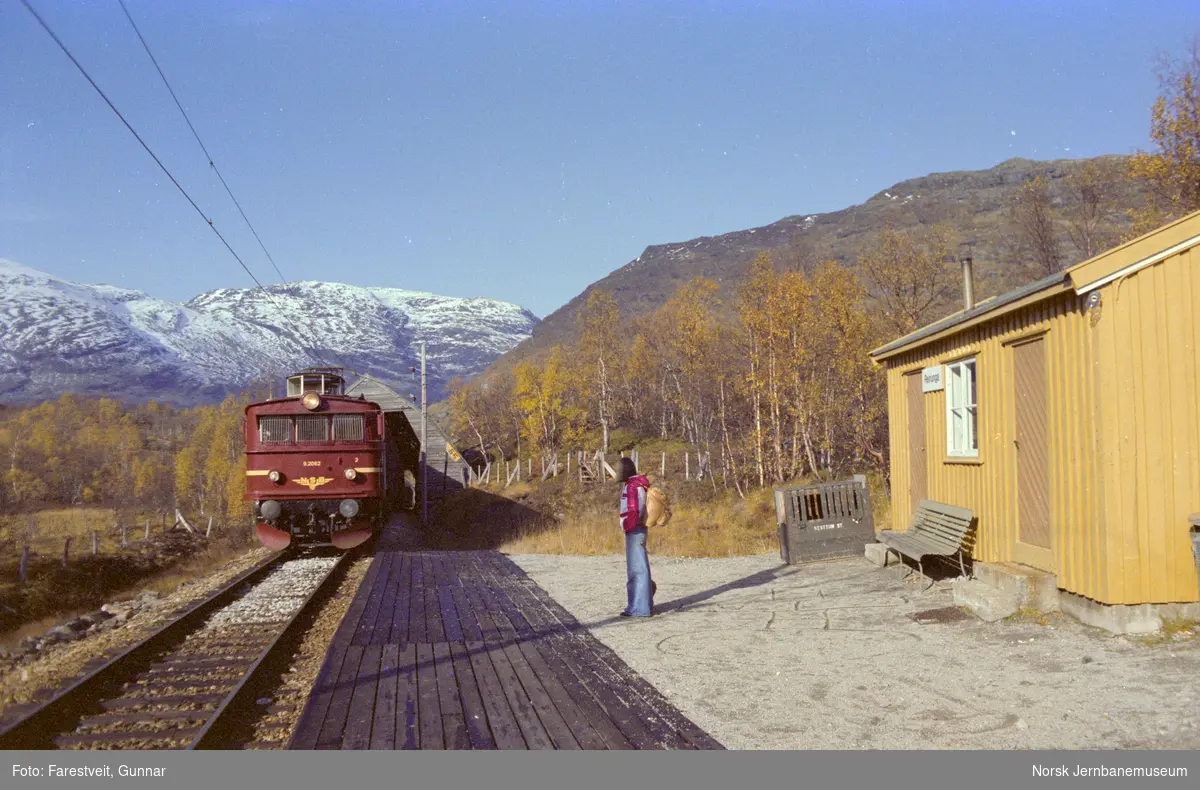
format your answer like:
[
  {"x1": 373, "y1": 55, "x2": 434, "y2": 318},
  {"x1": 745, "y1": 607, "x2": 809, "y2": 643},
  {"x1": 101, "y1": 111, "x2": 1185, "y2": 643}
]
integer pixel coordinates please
[{"x1": 0, "y1": 551, "x2": 358, "y2": 749}]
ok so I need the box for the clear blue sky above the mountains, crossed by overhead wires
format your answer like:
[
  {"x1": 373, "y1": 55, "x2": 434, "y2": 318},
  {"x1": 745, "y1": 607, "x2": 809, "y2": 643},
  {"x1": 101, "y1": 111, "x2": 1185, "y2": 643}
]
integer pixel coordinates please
[{"x1": 0, "y1": 0, "x2": 1200, "y2": 316}]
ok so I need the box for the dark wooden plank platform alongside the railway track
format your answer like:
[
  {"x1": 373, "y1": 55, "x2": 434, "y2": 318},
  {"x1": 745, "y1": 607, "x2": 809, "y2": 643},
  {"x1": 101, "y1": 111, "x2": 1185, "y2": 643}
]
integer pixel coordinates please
[{"x1": 289, "y1": 537, "x2": 722, "y2": 749}]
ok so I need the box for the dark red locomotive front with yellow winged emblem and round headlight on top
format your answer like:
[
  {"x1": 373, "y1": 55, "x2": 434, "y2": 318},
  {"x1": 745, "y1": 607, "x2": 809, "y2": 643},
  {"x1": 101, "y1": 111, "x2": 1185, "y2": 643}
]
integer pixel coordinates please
[{"x1": 246, "y1": 367, "x2": 390, "y2": 551}]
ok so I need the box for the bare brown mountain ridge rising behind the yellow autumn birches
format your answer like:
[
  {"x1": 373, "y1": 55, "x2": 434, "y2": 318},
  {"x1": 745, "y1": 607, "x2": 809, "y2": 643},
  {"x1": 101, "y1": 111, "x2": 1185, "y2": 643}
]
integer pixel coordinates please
[{"x1": 499, "y1": 155, "x2": 1145, "y2": 371}]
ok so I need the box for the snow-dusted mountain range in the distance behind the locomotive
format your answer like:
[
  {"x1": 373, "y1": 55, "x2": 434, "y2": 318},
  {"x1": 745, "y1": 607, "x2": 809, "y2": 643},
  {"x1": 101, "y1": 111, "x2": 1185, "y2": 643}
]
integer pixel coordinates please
[{"x1": 0, "y1": 259, "x2": 538, "y2": 405}]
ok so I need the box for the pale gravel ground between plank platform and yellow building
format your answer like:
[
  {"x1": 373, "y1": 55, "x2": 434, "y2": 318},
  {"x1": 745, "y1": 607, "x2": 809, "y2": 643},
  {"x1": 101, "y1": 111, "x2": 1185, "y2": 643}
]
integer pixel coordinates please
[{"x1": 511, "y1": 546, "x2": 1200, "y2": 749}]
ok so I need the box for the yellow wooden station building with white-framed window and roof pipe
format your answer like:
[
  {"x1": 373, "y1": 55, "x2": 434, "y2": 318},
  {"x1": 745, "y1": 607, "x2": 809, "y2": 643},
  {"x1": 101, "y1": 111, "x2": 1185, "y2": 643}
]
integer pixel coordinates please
[{"x1": 871, "y1": 207, "x2": 1200, "y2": 605}]
